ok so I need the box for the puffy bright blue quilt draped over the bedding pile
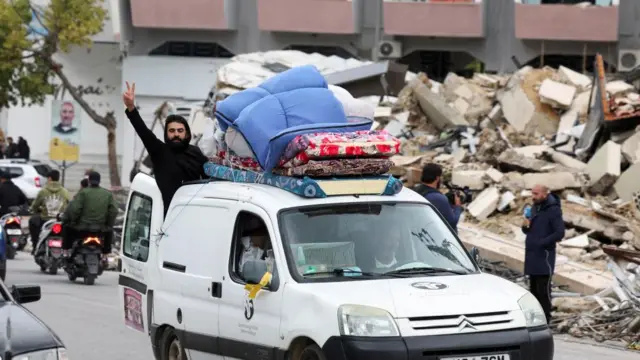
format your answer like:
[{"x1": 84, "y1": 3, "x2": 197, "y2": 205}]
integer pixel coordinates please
[{"x1": 216, "y1": 65, "x2": 372, "y2": 172}]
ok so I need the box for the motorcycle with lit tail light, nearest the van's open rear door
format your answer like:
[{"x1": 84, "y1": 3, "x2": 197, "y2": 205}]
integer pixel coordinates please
[{"x1": 64, "y1": 232, "x2": 104, "y2": 285}]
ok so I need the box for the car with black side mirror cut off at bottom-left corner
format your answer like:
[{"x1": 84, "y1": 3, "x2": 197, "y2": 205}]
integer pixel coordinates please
[{"x1": 0, "y1": 282, "x2": 69, "y2": 360}]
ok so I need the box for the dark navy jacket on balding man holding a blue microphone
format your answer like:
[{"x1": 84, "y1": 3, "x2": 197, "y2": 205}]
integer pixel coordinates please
[{"x1": 522, "y1": 194, "x2": 565, "y2": 275}]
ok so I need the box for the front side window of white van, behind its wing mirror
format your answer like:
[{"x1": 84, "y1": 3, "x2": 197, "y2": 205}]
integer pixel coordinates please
[{"x1": 229, "y1": 211, "x2": 274, "y2": 283}]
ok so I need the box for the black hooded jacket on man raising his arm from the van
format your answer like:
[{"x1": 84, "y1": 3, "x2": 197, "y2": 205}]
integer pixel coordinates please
[{"x1": 125, "y1": 109, "x2": 207, "y2": 215}]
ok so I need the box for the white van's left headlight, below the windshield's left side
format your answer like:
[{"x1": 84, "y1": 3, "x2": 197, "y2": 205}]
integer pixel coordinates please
[{"x1": 338, "y1": 305, "x2": 400, "y2": 336}]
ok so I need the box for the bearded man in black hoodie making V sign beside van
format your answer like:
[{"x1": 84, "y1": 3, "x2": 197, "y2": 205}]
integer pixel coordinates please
[{"x1": 122, "y1": 82, "x2": 207, "y2": 215}]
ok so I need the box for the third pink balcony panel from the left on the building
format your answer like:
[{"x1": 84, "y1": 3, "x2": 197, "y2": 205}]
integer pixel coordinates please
[{"x1": 384, "y1": 0, "x2": 484, "y2": 38}]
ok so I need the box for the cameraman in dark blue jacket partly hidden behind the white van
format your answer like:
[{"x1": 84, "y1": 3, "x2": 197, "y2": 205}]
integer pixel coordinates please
[{"x1": 415, "y1": 163, "x2": 462, "y2": 232}]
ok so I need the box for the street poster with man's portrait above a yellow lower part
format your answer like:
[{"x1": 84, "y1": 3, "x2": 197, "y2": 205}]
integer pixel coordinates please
[{"x1": 49, "y1": 100, "x2": 82, "y2": 161}]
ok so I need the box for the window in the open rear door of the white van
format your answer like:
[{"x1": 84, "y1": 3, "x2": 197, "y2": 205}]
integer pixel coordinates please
[{"x1": 122, "y1": 192, "x2": 153, "y2": 262}]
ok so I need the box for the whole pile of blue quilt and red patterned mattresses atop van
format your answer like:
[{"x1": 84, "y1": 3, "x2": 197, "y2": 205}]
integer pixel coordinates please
[{"x1": 201, "y1": 65, "x2": 400, "y2": 178}]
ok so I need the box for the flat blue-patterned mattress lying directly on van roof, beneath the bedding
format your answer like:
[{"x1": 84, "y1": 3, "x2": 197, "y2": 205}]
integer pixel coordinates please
[{"x1": 204, "y1": 162, "x2": 403, "y2": 198}]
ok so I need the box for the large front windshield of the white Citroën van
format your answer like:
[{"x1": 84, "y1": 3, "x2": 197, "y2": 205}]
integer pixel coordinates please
[{"x1": 279, "y1": 203, "x2": 477, "y2": 281}]
